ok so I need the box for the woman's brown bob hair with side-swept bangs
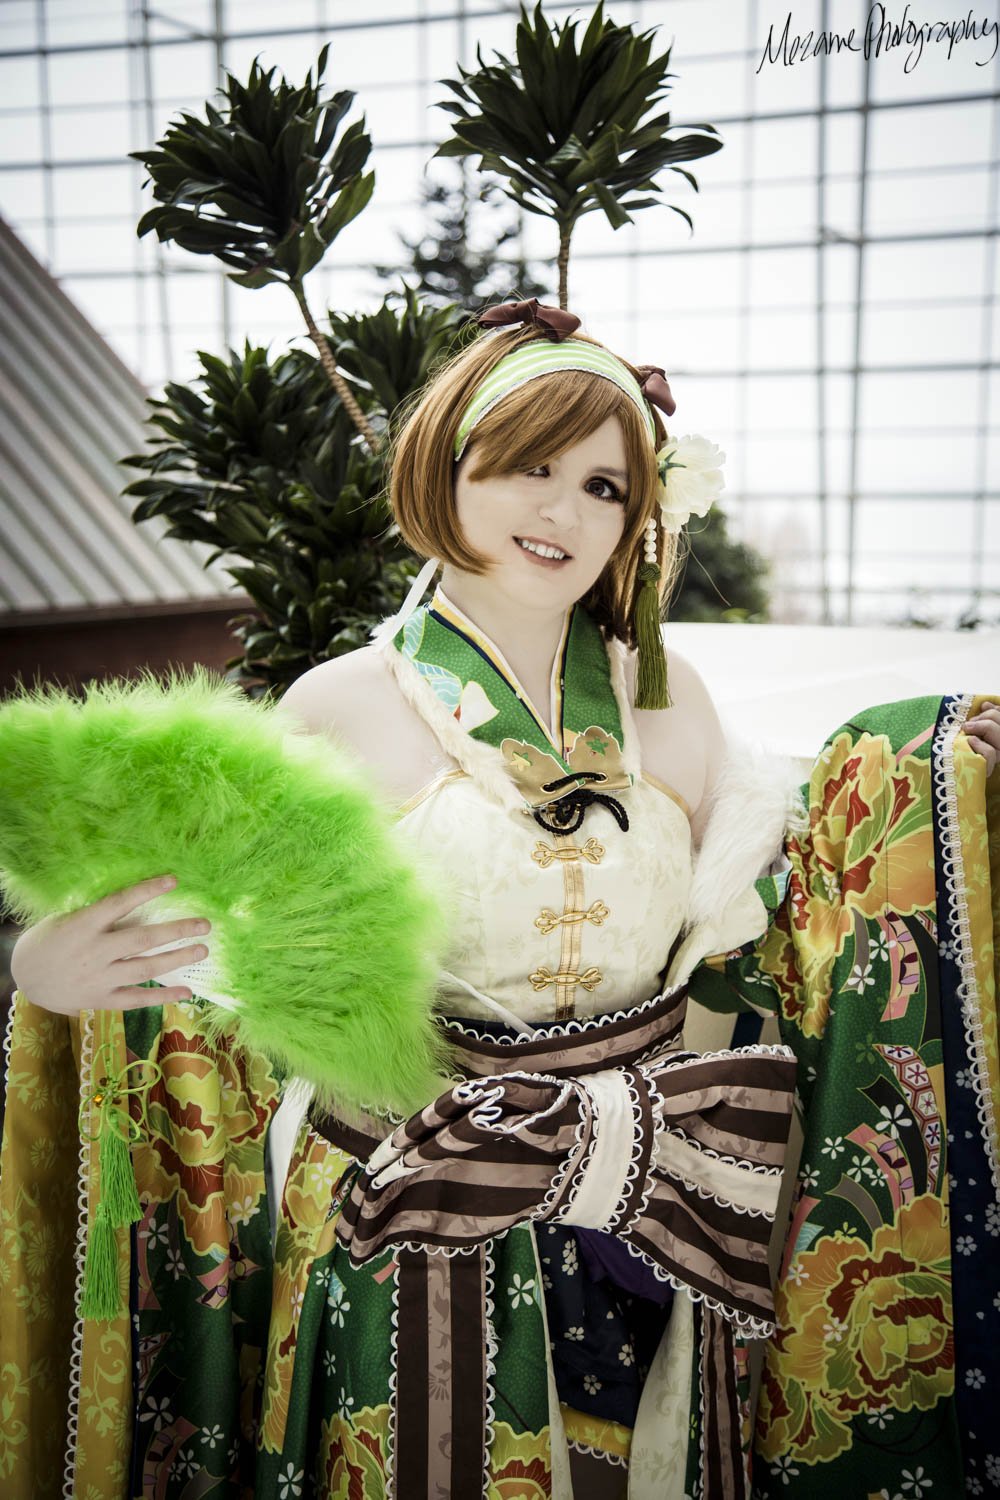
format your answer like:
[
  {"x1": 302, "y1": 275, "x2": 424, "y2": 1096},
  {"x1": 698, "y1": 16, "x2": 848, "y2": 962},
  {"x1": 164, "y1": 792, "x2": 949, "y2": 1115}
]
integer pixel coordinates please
[{"x1": 390, "y1": 327, "x2": 678, "y2": 647}]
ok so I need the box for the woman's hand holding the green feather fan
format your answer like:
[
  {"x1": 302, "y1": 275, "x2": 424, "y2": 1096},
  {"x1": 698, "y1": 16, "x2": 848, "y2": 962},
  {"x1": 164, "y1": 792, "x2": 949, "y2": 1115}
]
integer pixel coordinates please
[{"x1": 10, "y1": 876, "x2": 210, "y2": 1016}]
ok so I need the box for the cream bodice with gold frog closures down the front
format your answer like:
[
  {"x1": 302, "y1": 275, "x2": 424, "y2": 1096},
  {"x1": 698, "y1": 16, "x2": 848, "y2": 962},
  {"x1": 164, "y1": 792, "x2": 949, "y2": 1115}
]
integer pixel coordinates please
[{"x1": 399, "y1": 771, "x2": 691, "y2": 1025}]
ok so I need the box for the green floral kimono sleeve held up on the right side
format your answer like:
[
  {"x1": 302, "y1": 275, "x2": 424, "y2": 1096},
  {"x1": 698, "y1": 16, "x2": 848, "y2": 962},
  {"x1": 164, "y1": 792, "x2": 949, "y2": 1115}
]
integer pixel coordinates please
[{"x1": 693, "y1": 699, "x2": 1000, "y2": 1500}]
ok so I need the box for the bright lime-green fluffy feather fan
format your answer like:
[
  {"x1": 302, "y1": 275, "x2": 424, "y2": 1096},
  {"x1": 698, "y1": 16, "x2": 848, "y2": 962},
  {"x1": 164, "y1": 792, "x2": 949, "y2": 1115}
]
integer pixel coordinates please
[{"x1": 0, "y1": 668, "x2": 447, "y2": 1116}]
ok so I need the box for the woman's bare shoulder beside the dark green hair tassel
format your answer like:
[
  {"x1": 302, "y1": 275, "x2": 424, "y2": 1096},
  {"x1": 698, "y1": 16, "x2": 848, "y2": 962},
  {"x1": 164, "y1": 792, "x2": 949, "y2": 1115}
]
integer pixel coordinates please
[{"x1": 624, "y1": 648, "x2": 726, "y2": 834}]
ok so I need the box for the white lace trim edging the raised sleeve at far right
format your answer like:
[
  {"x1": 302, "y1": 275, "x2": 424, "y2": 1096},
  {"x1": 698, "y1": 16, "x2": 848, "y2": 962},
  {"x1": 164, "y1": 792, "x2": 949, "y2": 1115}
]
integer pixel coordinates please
[{"x1": 931, "y1": 693, "x2": 1000, "y2": 1199}]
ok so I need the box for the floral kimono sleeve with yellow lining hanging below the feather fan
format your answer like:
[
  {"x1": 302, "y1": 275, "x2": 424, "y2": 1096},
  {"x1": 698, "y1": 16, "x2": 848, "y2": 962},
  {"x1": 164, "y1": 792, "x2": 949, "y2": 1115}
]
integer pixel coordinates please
[{"x1": 0, "y1": 996, "x2": 279, "y2": 1500}]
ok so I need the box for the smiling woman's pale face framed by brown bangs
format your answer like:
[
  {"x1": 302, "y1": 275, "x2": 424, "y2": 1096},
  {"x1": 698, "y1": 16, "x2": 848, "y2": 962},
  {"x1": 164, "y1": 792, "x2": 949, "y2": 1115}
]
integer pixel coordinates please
[{"x1": 454, "y1": 417, "x2": 628, "y2": 609}]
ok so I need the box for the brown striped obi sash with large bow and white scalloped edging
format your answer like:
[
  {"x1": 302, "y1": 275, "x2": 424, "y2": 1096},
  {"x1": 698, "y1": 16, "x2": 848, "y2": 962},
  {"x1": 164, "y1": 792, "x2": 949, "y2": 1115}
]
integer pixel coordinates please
[{"x1": 316, "y1": 987, "x2": 795, "y2": 1500}]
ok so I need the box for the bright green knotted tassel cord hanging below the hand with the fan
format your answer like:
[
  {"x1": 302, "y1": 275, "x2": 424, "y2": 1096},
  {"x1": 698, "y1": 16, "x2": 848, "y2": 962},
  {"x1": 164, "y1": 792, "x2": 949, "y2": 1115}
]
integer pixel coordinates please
[{"x1": 79, "y1": 1043, "x2": 162, "y2": 1320}]
